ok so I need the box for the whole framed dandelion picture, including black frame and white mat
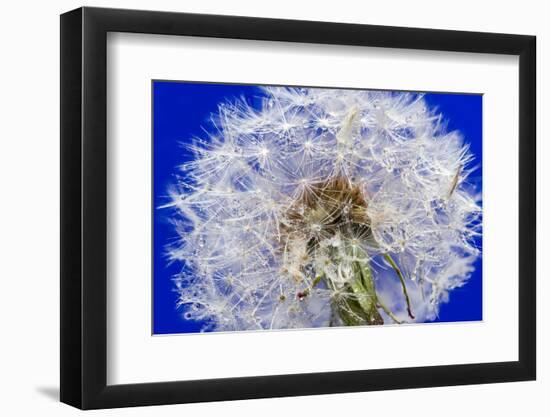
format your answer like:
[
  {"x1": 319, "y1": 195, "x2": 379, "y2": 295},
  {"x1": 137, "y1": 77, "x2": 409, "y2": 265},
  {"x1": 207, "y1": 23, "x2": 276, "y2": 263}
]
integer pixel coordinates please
[{"x1": 61, "y1": 7, "x2": 536, "y2": 409}]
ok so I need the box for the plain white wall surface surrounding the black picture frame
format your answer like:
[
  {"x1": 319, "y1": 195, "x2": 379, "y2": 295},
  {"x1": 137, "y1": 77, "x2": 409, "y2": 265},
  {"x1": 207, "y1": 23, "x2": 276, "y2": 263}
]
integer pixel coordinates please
[{"x1": 0, "y1": 0, "x2": 550, "y2": 417}]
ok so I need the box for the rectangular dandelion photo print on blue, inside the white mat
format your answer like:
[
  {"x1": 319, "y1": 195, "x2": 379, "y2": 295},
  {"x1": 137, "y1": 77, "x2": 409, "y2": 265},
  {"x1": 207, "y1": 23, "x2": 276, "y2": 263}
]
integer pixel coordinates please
[{"x1": 152, "y1": 80, "x2": 483, "y2": 334}]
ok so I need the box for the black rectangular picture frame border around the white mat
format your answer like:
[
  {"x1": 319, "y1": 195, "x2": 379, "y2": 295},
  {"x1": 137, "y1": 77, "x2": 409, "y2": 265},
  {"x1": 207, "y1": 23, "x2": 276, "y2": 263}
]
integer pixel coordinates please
[{"x1": 60, "y1": 7, "x2": 536, "y2": 409}]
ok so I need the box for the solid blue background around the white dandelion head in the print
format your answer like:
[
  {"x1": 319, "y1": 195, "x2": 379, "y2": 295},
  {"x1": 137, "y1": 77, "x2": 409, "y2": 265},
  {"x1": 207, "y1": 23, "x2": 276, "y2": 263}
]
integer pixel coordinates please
[{"x1": 153, "y1": 81, "x2": 482, "y2": 334}]
